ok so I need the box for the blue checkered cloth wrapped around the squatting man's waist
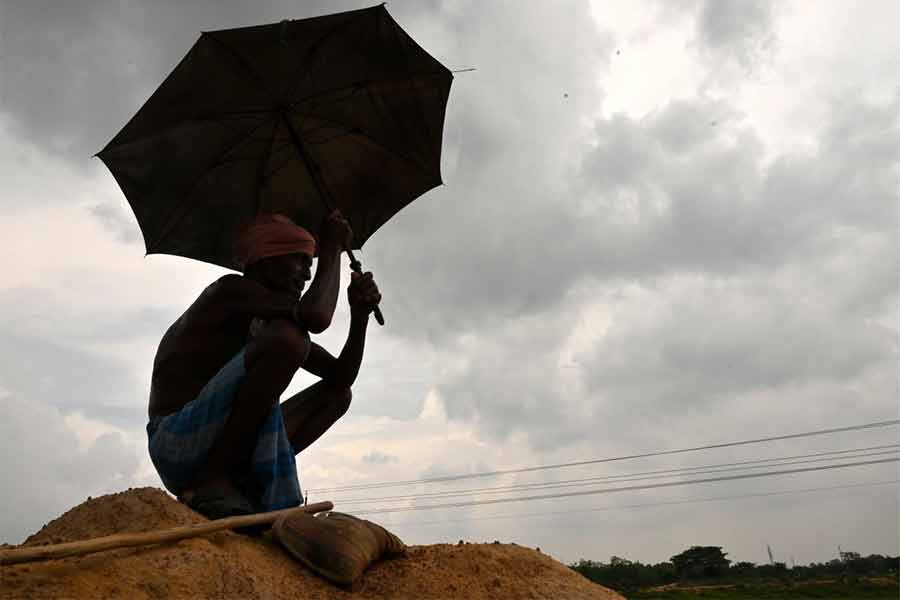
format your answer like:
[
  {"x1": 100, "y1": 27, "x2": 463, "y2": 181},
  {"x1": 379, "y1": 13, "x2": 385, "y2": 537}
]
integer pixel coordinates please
[{"x1": 147, "y1": 349, "x2": 303, "y2": 511}]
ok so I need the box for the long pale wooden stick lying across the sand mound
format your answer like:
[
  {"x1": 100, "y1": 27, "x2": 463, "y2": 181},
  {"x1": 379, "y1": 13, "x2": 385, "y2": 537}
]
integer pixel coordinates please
[{"x1": 0, "y1": 502, "x2": 334, "y2": 565}]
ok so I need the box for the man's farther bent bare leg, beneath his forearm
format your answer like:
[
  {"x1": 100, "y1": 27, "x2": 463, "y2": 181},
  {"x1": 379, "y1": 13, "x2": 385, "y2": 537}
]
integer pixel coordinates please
[{"x1": 281, "y1": 381, "x2": 353, "y2": 453}]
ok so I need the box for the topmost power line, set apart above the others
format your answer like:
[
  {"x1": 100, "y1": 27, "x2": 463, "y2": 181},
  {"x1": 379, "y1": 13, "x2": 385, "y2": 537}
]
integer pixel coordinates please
[{"x1": 310, "y1": 419, "x2": 900, "y2": 493}]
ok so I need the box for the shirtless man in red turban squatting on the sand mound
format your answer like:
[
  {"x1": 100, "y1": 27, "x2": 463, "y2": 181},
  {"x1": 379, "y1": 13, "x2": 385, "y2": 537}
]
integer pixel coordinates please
[{"x1": 147, "y1": 211, "x2": 381, "y2": 519}]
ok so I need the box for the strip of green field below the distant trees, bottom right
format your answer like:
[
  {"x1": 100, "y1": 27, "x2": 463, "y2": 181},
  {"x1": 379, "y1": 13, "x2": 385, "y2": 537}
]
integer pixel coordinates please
[{"x1": 626, "y1": 577, "x2": 900, "y2": 600}]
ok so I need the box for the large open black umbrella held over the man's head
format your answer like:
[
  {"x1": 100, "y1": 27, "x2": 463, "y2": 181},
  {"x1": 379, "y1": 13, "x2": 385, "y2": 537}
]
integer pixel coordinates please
[{"x1": 97, "y1": 5, "x2": 453, "y2": 323}]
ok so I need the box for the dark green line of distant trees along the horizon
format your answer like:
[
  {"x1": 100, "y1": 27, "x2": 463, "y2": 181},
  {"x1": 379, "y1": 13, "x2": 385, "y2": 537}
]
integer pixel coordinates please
[{"x1": 569, "y1": 546, "x2": 900, "y2": 592}]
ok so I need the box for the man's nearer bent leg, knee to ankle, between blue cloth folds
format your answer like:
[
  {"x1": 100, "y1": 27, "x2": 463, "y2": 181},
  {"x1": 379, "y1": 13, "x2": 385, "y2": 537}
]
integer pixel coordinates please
[{"x1": 187, "y1": 319, "x2": 310, "y2": 497}]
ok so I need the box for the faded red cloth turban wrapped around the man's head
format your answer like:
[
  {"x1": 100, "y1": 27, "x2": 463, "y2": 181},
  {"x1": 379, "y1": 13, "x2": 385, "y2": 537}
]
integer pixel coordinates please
[{"x1": 235, "y1": 214, "x2": 316, "y2": 269}]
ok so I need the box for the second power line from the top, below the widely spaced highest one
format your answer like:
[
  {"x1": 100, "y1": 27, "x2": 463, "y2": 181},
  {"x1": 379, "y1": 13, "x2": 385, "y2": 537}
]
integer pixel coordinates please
[{"x1": 339, "y1": 444, "x2": 900, "y2": 505}]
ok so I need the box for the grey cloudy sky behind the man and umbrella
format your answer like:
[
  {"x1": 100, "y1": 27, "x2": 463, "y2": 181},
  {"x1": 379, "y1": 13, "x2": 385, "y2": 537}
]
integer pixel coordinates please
[{"x1": 0, "y1": 0, "x2": 900, "y2": 564}]
